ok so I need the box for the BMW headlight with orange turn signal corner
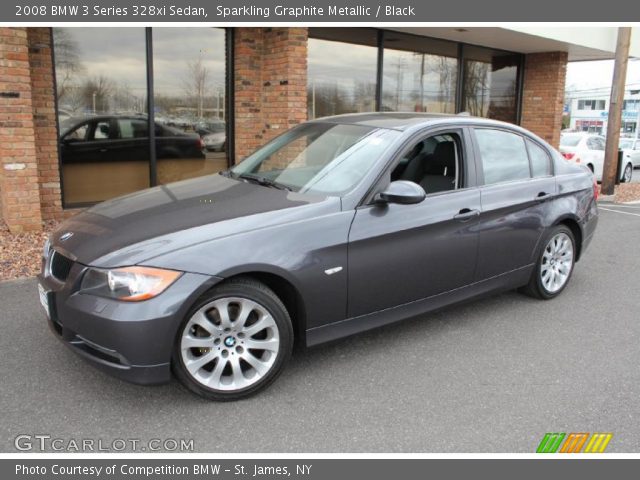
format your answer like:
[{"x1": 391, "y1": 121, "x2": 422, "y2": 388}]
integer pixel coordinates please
[{"x1": 80, "y1": 267, "x2": 182, "y2": 302}]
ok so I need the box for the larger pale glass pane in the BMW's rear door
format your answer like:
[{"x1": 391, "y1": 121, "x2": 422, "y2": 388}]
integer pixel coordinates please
[{"x1": 475, "y1": 128, "x2": 530, "y2": 185}]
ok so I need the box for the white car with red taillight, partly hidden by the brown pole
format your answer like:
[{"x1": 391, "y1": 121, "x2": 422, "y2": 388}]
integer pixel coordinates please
[{"x1": 560, "y1": 132, "x2": 633, "y2": 182}]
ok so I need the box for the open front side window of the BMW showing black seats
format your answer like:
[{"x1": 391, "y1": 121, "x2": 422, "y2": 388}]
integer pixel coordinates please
[{"x1": 391, "y1": 133, "x2": 462, "y2": 195}]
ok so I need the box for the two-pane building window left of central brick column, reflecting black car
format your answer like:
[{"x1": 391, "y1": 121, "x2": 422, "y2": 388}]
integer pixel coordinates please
[{"x1": 53, "y1": 28, "x2": 228, "y2": 206}]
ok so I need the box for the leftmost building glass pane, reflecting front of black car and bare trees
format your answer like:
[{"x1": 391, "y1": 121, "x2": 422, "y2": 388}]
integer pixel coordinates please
[{"x1": 53, "y1": 28, "x2": 149, "y2": 205}]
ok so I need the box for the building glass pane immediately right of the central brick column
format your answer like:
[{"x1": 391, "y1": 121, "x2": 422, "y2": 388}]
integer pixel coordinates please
[{"x1": 307, "y1": 28, "x2": 378, "y2": 118}]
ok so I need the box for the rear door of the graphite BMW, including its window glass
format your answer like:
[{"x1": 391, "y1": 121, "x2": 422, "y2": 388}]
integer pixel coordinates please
[{"x1": 474, "y1": 127, "x2": 556, "y2": 281}]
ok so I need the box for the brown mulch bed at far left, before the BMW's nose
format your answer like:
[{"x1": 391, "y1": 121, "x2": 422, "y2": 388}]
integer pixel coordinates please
[{"x1": 0, "y1": 221, "x2": 57, "y2": 282}]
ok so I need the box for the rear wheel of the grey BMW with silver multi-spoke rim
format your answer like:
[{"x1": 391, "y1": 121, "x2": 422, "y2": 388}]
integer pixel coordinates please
[{"x1": 522, "y1": 225, "x2": 576, "y2": 300}]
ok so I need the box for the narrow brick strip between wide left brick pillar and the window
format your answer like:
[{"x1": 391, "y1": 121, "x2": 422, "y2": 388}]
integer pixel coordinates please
[{"x1": 27, "y1": 28, "x2": 63, "y2": 220}]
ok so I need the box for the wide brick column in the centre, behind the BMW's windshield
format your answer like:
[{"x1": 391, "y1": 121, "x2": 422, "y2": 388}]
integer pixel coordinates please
[{"x1": 234, "y1": 27, "x2": 307, "y2": 161}]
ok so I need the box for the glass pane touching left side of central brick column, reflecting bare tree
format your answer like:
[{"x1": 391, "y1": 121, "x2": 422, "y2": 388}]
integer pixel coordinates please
[{"x1": 153, "y1": 28, "x2": 227, "y2": 183}]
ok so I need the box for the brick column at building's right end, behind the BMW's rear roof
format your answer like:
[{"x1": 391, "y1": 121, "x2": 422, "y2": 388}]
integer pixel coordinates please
[{"x1": 521, "y1": 52, "x2": 567, "y2": 148}]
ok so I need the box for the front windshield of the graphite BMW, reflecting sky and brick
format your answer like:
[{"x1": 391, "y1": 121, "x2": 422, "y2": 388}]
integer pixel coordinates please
[{"x1": 231, "y1": 122, "x2": 400, "y2": 195}]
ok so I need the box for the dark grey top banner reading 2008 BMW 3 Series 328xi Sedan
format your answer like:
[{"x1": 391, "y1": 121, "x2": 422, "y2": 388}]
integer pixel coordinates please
[{"x1": 0, "y1": 0, "x2": 640, "y2": 24}]
